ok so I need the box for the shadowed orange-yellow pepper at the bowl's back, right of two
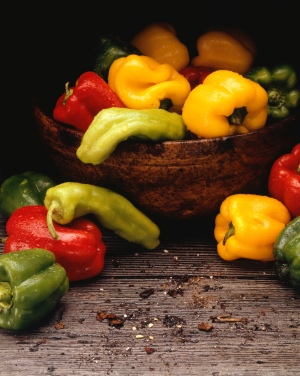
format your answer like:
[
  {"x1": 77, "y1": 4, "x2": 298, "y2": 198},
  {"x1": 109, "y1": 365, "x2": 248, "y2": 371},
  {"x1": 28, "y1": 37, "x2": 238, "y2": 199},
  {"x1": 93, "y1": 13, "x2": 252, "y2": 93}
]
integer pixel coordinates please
[{"x1": 191, "y1": 29, "x2": 256, "y2": 74}]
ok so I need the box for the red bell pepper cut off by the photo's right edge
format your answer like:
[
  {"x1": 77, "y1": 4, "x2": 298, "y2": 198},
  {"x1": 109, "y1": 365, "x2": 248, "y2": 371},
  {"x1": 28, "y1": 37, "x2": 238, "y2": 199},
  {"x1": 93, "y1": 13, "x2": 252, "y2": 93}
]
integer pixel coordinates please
[{"x1": 268, "y1": 143, "x2": 300, "y2": 217}]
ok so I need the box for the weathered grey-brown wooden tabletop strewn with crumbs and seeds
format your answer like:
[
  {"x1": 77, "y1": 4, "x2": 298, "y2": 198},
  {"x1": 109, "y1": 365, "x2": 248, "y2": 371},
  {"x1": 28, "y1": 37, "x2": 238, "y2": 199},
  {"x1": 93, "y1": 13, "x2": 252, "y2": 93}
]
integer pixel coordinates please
[{"x1": 0, "y1": 213, "x2": 300, "y2": 376}]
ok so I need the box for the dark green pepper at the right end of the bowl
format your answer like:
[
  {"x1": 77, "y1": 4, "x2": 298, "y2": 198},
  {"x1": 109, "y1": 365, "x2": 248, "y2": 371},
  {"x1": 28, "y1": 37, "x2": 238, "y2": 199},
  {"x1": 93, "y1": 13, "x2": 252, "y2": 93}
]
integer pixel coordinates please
[{"x1": 245, "y1": 64, "x2": 300, "y2": 123}]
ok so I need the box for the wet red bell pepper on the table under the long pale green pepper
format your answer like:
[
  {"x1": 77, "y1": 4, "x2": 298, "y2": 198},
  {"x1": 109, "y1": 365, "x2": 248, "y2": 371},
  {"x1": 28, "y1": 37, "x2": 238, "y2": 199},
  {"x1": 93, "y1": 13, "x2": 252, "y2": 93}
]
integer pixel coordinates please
[{"x1": 4, "y1": 205, "x2": 106, "y2": 281}]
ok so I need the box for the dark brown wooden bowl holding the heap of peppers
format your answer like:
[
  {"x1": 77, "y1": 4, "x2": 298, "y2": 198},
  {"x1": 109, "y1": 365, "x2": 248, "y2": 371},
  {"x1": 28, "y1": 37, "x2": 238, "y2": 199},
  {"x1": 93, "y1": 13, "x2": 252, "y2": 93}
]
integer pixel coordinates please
[{"x1": 33, "y1": 101, "x2": 300, "y2": 220}]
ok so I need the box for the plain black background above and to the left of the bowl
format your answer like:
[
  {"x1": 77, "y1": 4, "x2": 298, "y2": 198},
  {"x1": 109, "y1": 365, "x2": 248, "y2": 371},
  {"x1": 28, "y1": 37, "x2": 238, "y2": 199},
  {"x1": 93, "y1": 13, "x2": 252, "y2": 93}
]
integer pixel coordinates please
[{"x1": 0, "y1": 1, "x2": 300, "y2": 183}]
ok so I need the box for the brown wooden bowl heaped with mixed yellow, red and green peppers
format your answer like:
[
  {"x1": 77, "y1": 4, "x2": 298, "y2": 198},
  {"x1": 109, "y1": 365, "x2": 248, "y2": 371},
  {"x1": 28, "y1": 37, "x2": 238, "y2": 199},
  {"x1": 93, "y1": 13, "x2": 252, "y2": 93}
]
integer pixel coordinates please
[{"x1": 33, "y1": 28, "x2": 300, "y2": 221}]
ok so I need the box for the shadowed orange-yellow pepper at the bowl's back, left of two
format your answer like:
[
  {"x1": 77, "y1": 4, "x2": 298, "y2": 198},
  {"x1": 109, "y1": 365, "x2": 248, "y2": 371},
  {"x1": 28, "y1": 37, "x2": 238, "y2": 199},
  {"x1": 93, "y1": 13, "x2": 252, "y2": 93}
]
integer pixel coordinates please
[{"x1": 131, "y1": 22, "x2": 190, "y2": 71}]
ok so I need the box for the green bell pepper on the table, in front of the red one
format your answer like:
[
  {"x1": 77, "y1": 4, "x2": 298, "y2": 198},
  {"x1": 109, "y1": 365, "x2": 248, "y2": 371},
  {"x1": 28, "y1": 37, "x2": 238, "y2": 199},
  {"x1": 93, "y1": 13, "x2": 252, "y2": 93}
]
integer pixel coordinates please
[{"x1": 0, "y1": 248, "x2": 69, "y2": 330}]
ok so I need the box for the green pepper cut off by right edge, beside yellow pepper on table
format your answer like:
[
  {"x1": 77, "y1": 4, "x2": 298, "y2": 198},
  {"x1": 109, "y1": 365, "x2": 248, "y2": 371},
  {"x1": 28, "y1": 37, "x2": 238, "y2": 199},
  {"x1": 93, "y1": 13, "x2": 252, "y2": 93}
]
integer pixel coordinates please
[{"x1": 274, "y1": 216, "x2": 300, "y2": 293}]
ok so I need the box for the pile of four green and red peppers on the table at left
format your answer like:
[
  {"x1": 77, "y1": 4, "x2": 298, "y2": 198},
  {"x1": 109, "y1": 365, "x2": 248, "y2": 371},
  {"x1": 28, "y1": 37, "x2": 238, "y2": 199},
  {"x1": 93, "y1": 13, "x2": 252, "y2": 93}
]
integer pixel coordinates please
[{"x1": 0, "y1": 172, "x2": 162, "y2": 330}]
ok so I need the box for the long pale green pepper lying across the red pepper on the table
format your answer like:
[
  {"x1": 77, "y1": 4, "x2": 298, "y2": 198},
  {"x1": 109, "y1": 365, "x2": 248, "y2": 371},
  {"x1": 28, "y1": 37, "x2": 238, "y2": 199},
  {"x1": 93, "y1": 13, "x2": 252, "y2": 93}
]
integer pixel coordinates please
[{"x1": 45, "y1": 182, "x2": 160, "y2": 249}]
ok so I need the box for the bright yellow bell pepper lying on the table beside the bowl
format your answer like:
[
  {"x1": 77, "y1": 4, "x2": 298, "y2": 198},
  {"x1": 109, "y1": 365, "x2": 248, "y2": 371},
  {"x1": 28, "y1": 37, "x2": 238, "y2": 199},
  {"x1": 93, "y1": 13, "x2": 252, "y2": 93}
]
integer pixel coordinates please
[{"x1": 214, "y1": 194, "x2": 291, "y2": 261}]
